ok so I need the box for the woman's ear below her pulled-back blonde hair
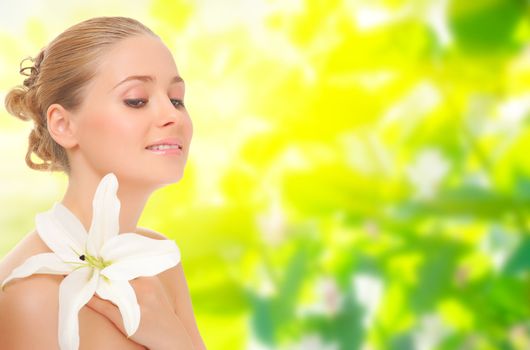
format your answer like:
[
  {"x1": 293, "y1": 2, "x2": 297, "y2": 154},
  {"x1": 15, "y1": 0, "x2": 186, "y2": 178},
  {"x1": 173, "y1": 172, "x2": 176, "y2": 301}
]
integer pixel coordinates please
[{"x1": 46, "y1": 103, "x2": 77, "y2": 149}]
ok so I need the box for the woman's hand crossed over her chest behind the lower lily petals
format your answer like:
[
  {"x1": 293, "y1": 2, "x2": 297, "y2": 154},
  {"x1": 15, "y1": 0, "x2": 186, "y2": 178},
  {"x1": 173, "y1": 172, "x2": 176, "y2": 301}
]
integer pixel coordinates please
[{"x1": 87, "y1": 276, "x2": 193, "y2": 350}]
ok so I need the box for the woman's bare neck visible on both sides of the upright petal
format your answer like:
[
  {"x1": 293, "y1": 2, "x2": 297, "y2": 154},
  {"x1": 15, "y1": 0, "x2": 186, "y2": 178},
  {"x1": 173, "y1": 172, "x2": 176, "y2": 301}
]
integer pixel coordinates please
[{"x1": 61, "y1": 173, "x2": 151, "y2": 233}]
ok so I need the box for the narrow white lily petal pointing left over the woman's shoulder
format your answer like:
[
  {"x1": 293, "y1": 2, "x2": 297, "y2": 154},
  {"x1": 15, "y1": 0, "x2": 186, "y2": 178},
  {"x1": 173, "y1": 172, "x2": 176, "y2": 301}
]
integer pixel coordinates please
[{"x1": 1, "y1": 253, "x2": 74, "y2": 289}]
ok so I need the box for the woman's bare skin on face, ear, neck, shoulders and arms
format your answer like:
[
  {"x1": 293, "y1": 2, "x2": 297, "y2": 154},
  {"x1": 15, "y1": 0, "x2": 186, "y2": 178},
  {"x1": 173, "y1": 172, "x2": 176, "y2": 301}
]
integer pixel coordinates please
[{"x1": 0, "y1": 35, "x2": 206, "y2": 350}]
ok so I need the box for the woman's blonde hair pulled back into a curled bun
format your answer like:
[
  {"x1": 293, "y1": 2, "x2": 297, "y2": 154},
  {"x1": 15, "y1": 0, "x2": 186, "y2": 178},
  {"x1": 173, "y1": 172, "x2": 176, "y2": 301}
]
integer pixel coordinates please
[{"x1": 5, "y1": 17, "x2": 158, "y2": 174}]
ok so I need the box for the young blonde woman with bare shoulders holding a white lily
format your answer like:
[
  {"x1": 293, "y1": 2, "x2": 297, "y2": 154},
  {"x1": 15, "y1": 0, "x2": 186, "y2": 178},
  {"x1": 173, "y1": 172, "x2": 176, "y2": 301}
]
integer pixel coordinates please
[{"x1": 0, "y1": 17, "x2": 205, "y2": 350}]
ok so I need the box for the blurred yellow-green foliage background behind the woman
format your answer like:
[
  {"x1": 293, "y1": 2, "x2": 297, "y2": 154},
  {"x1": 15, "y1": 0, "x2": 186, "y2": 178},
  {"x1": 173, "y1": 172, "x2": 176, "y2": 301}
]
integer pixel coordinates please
[{"x1": 0, "y1": 0, "x2": 530, "y2": 350}]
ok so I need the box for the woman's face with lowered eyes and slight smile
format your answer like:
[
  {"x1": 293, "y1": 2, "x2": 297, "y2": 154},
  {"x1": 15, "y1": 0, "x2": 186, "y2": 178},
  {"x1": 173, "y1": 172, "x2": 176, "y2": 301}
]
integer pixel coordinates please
[{"x1": 71, "y1": 35, "x2": 193, "y2": 187}]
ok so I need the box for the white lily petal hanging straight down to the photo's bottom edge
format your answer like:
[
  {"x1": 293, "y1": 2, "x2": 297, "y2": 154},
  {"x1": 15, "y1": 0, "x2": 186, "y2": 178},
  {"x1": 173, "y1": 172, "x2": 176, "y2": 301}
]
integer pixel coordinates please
[{"x1": 59, "y1": 267, "x2": 99, "y2": 350}]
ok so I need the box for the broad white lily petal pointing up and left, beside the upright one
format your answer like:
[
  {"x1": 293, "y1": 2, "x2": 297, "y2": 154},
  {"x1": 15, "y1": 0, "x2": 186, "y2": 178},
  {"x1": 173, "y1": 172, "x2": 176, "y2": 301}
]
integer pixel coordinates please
[{"x1": 35, "y1": 203, "x2": 87, "y2": 261}]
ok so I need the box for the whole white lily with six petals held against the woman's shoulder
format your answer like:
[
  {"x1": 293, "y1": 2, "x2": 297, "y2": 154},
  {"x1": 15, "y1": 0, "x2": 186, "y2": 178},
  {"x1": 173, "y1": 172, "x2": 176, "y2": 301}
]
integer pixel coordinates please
[{"x1": 2, "y1": 173, "x2": 180, "y2": 350}]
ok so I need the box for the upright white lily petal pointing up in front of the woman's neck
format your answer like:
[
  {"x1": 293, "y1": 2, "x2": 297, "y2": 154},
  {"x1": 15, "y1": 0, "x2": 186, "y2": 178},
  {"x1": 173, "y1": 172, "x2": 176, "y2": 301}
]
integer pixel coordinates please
[{"x1": 87, "y1": 173, "x2": 120, "y2": 256}]
